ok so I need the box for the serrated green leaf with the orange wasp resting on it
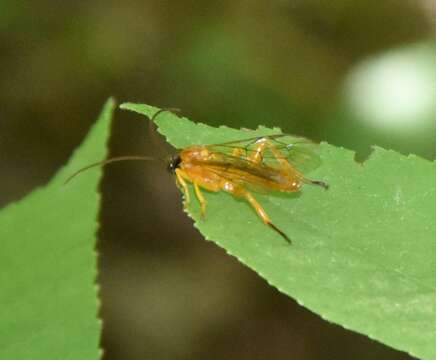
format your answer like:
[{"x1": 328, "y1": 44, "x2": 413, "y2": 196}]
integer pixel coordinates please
[{"x1": 122, "y1": 104, "x2": 436, "y2": 359}]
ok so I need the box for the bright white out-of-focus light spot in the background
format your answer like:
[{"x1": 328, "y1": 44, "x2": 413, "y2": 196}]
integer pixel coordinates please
[{"x1": 345, "y1": 45, "x2": 436, "y2": 131}]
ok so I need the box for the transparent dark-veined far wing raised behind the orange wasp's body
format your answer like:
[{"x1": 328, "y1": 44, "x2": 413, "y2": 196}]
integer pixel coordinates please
[{"x1": 208, "y1": 134, "x2": 321, "y2": 173}]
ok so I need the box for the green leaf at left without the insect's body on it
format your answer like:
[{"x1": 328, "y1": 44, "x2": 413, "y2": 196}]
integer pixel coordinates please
[{"x1": 0, "y1": 100, "x2": 114, "y2": 360}]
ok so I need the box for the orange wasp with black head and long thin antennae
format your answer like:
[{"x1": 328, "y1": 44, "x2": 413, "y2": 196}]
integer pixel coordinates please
[{"x1": 66, "y1": 110, "x2": 328, "y2": 243}]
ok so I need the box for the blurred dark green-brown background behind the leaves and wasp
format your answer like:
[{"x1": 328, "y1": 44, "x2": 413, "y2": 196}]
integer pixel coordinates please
[{"x1": 0, "y1": 0, "x2": 436, "y2": 360}]
